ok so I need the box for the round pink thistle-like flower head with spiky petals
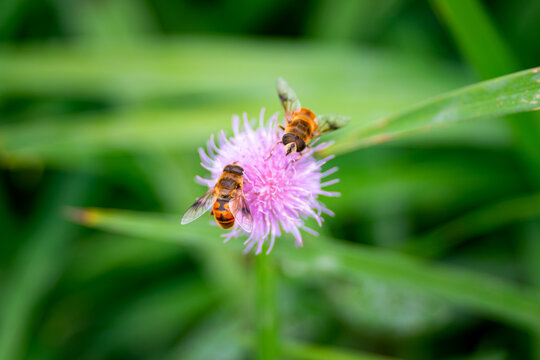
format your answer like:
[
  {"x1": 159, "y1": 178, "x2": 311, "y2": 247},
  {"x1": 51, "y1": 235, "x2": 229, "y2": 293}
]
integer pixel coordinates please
[{"x1": 196, "y1": 108, "x2": 340, "y2": 254}]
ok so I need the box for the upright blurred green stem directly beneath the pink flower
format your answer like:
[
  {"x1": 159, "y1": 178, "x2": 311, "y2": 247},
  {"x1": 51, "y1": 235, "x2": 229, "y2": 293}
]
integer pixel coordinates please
[{"x1": 255, "y1": 253, "x2": 278, "y2": 360}]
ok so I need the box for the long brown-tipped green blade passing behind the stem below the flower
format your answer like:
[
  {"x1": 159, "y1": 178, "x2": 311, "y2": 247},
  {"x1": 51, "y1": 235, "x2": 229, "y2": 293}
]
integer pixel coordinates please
[{"x1": 68, "y1": 209, "x2": 540, "y2": 327}]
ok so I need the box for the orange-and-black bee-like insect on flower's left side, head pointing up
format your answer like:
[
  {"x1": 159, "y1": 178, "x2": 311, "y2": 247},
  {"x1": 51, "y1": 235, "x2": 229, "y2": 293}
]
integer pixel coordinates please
[{"x1": 182, "y1": 163, "x2": 253, "y2": 232}]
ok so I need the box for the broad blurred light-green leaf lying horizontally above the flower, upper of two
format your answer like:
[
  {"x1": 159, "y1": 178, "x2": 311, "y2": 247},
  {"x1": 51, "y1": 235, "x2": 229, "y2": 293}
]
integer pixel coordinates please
[{"x1": 0, "y1": 37, "x2": 465, "y2": 101}]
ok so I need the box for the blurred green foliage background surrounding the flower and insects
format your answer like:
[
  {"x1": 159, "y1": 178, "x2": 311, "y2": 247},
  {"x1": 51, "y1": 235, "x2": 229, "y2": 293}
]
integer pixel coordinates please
[{"x1": 0, "y1": 0, "x2": 540, "y2": 360}]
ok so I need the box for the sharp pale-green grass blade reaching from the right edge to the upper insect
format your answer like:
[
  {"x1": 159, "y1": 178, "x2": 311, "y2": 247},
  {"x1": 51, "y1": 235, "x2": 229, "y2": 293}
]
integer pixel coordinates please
[{"x1": 329, "y1": 68, "x2": 540, "y2": 153}]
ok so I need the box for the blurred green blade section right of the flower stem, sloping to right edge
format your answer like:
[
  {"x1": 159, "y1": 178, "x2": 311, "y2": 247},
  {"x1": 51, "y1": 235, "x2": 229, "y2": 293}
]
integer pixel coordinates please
[{"x1": 276, "y1": 240, "x2": 540, "y2": 327}]
